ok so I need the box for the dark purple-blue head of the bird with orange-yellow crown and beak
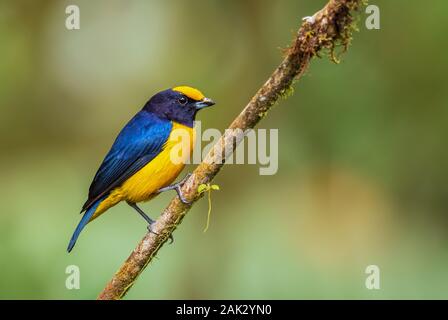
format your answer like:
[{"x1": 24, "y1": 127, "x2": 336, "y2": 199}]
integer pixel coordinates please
[{"x1": 143, "y1": 86, "x2": 215, "y2": 127}]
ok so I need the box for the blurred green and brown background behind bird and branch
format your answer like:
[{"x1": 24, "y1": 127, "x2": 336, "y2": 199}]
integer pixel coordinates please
[{"x1": 0, "y1": 0, "x2": 448, "y2": 299}]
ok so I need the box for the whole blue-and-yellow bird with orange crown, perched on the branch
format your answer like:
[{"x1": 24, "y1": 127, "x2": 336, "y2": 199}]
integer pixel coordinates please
[{"x1": 67, "y1": 86, "x2": 215, "y2": 252}]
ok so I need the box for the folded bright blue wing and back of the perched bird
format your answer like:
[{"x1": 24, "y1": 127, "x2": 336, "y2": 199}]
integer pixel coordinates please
[{"x1": 81, "y1": 111, "x2": 173, "y2": 212}]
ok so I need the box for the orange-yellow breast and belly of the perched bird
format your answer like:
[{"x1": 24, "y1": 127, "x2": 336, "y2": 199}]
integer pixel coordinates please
[{"x1": 91, "y1": 122, "x2": 195, "y2": 220}]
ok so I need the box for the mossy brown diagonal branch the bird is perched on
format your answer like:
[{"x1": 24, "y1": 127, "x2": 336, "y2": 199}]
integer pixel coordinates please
[{"x1": 98, "y1": 0, "x2": 363, "y2": 300}]
